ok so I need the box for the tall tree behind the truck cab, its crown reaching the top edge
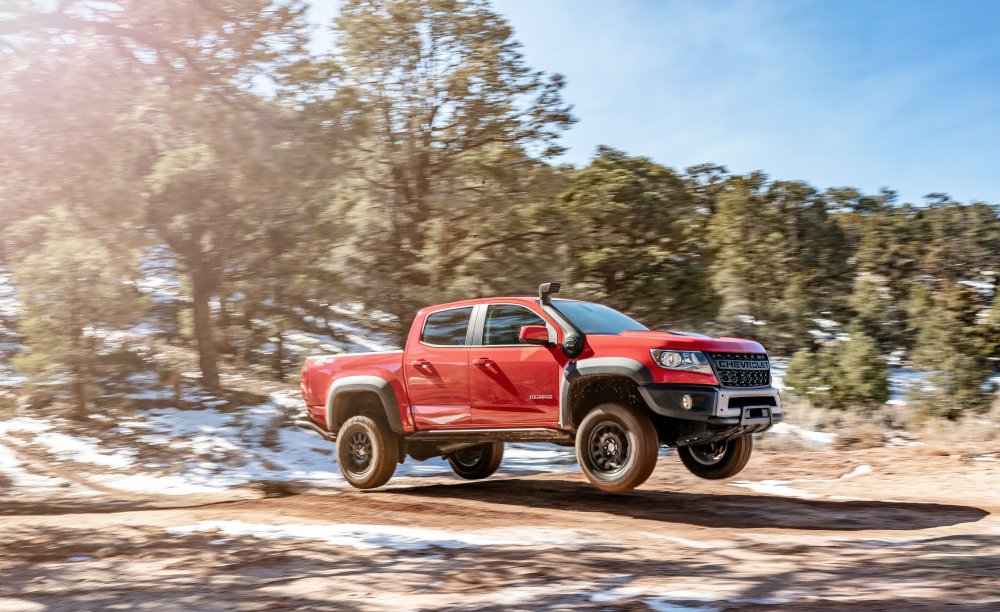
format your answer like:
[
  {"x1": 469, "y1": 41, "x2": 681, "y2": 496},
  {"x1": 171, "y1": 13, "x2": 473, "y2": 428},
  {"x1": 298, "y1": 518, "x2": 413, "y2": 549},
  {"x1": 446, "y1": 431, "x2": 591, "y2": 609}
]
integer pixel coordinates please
[{"x1": 333, "y1": 0, "x2": 572, "y2": 335}]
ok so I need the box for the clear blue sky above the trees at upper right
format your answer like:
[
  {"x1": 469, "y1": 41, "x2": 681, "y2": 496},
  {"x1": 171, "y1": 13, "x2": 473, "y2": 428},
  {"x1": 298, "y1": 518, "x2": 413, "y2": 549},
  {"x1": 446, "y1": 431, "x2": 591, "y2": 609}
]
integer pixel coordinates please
[{"x1": 306, "y1": 0, "x2": 1000, "y2": 202}]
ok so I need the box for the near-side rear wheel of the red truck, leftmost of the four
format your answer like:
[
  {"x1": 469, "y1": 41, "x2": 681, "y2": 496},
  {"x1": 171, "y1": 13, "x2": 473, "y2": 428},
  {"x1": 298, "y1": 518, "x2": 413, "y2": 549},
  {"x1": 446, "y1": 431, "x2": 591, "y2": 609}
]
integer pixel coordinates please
[{"x1": 337, "y1": 416, "x2": 399, "y2": 489}]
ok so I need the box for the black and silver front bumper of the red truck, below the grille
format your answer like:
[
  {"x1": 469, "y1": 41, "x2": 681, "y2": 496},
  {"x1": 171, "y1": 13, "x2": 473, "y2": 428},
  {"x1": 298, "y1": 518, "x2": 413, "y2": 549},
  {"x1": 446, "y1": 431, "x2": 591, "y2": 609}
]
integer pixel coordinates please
[{"x1": 639, "y1": 383, "x2": 784, "y2": 433}]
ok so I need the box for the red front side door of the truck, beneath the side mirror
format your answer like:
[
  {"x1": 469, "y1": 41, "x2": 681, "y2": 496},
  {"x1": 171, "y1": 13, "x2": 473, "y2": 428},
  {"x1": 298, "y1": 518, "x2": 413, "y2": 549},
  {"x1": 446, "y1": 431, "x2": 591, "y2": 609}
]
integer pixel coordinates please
[{"x1": 469, "y1": 304, "x2": 562, "y2": 428}]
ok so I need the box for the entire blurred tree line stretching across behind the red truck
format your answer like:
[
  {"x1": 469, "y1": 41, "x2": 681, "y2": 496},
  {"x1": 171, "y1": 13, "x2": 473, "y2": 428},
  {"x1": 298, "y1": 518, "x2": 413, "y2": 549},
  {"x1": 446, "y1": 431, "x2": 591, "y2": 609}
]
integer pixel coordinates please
[{"x1": 0, "y1": 0, "x2": 1000, "y2": 426}]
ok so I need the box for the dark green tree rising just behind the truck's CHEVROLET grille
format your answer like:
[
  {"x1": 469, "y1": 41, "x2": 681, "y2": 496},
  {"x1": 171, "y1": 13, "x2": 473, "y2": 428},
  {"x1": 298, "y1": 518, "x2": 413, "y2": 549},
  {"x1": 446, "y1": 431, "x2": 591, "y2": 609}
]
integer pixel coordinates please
[{"x1": 709, "y1": 173, "x2": 851, "y2": 353}]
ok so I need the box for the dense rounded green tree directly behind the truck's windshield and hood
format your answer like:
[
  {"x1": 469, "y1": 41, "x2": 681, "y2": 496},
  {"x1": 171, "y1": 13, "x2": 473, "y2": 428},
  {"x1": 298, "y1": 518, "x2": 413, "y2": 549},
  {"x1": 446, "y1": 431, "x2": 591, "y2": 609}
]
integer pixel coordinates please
[{"x1": 559, "y1": 147, "x2": 715, "y2": 328}]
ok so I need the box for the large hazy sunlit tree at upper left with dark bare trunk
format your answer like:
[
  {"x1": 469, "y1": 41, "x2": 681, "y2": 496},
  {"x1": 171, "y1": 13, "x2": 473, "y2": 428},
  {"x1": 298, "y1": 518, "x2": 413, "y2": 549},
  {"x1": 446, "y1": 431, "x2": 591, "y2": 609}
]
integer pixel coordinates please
[{"x1": 0, "y1": 0, "x2": 320, "y2": 388}]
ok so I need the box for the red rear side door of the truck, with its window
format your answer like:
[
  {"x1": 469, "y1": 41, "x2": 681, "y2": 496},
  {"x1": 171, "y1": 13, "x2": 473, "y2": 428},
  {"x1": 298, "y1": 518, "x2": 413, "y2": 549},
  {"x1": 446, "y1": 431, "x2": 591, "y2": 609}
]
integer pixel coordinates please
[{"x1": 403, "y1": 306, "x2": 473, "y2": 429}]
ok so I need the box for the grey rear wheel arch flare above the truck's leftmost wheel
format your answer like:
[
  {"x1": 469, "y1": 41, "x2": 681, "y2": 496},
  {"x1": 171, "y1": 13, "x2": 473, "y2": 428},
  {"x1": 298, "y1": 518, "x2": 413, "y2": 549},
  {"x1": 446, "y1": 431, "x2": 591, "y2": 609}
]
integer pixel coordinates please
[{"x1": 326, "y1": 376, "x2": 404, "y2": 434}]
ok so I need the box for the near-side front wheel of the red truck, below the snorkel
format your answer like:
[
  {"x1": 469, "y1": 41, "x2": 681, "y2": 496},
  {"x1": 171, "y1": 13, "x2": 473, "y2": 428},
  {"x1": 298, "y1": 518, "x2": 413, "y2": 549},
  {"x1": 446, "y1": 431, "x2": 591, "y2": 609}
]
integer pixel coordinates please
[{"x1": 576, "y1": 403, "x2": 660, "y2": 493}]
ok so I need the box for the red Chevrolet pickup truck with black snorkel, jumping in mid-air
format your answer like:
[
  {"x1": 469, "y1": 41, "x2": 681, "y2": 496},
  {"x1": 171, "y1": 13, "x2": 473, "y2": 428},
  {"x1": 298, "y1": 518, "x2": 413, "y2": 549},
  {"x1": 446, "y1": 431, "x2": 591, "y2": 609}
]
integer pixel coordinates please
[{"x1": 295, "y1": 283, "x2": 782, "y2": 492}]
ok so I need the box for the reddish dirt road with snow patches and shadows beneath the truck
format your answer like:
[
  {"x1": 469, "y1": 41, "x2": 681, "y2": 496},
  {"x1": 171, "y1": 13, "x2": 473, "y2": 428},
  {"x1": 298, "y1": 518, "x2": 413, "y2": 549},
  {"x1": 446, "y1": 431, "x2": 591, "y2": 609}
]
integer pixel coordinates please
[{"x1": 0, "y1": 448, "x2": 1000, "y2": 610}]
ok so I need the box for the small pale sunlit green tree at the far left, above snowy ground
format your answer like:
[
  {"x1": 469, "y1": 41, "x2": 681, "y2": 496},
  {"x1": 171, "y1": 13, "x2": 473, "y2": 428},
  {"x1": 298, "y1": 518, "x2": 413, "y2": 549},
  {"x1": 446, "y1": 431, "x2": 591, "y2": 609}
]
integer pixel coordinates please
[{"x1": 12, "y1": 208, "x2": 144, "y2": 416}]
